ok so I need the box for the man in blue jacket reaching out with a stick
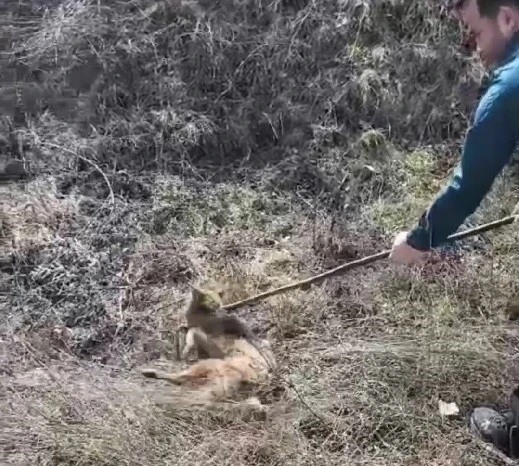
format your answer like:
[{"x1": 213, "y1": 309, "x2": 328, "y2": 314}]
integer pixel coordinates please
[{"x1": 390, "y1": 0, "x2": 519, "y2": 457}]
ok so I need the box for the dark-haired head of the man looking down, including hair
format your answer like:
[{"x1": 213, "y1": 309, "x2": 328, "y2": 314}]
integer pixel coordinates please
[{"x1": 449, "y1": 0, "x2": 519, "y2": 67}]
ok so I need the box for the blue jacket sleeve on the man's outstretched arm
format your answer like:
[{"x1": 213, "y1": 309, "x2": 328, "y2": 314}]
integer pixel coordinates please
[{"x1": 407, "y1": 36, "x2": 519, "y2": 251}]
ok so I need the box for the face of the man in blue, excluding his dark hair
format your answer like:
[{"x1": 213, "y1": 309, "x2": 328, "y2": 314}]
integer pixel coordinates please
[{"x1": 457, "y1": 0, "x2": 519, "y2": 68}]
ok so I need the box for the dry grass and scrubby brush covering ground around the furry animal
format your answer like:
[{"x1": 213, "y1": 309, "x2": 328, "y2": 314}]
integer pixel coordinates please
[{"x1": 0, "y1": 0, "x2": 519, "y2": 466}]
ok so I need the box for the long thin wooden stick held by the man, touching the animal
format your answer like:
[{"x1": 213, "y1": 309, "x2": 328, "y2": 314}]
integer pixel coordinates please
[{"x1": 223, "y1": 215, "x2": 516, "y2": 310}]
